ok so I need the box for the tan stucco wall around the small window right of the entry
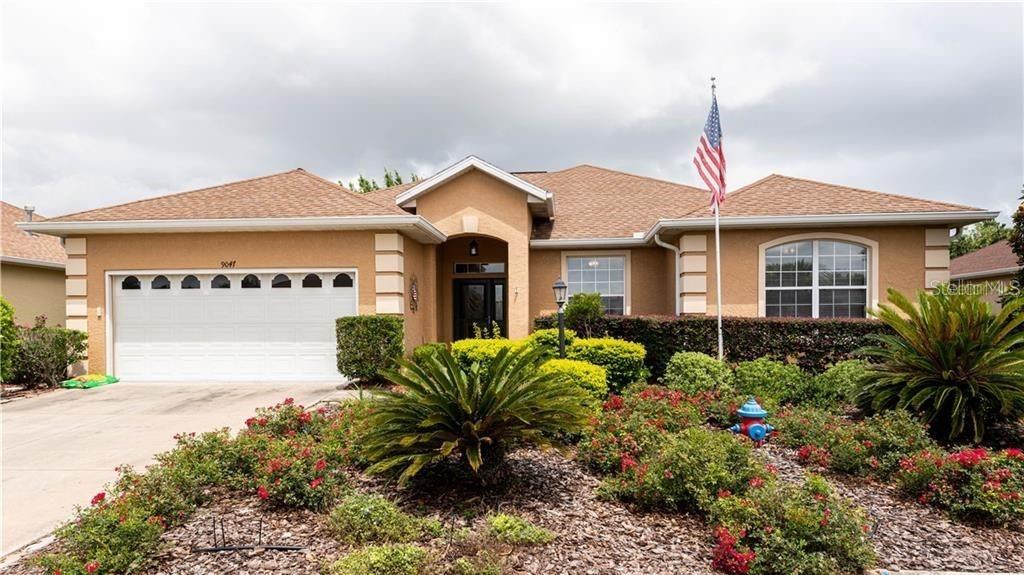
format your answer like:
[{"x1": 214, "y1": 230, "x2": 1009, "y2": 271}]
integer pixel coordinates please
[{"x1": 529, "y1": 248, "x2": 676, "y2": 317}]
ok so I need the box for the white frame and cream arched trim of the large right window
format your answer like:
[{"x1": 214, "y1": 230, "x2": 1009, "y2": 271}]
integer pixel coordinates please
[{"x1": 758, "y1": 232, "x2": 879, "y2": 317}]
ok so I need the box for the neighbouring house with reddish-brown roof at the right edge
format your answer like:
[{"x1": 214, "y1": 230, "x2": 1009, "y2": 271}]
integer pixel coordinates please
[{"x1": 949, "y1": 239, "x2": 1021, "y2": 310}]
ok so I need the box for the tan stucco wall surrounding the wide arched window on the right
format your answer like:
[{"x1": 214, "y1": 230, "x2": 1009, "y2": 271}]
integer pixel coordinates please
[{"x1": 708, "y1": 226, "x2": 937, "y2": 316}]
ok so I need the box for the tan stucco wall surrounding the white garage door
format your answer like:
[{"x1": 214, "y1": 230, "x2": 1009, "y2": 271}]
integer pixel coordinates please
[{"x1": 76, "y1": 231, "x2": 380, "y2": 372}]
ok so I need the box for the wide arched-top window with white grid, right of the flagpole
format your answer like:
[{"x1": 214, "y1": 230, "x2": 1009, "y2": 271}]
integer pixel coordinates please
[{"x1": 764, "y1": 239, "x2": 868, "y2": 317}]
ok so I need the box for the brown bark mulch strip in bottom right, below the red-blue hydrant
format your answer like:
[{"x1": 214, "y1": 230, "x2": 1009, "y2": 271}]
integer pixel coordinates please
[{"x1": 760, "y1": 444, "x2": 1024, "y2": 573}]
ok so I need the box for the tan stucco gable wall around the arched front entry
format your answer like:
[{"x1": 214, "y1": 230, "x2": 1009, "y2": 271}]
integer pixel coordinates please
[{"x1": 416, "y1": 170, "x2": 532, "y2": 339}]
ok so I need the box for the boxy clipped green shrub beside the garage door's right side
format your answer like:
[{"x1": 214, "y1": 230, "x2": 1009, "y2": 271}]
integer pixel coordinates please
[{"x1": 337, "y1": 315, "x2": 406, "y2": 382}]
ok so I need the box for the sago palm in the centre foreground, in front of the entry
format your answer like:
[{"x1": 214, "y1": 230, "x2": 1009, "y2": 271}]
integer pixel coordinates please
[{"x1": 365, "y1": 341, "x2": 588, "y2": 482}]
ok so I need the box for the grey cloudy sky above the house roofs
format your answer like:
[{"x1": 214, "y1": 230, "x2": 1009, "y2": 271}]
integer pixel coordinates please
[{"x1": 2, "y1": 2, "x2": 1024, "y2": 216}]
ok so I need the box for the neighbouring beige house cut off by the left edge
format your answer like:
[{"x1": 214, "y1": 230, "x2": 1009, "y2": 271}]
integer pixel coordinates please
[{"x1": 0, "y1": 202, "x2": 68, "y2": 325}]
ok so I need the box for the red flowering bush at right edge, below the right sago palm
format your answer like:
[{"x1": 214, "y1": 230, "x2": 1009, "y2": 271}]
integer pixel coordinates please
[{"x1": 896, "y1": 447, "x2": 1024, "y2": 524}]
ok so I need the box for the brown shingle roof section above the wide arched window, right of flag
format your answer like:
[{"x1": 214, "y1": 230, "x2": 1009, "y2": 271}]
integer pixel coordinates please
[{"x1": 689, "y1": 174, "x2": 978, "y2": 217}]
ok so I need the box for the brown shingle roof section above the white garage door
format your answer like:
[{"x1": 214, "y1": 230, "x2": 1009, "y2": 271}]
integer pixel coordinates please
[{"x1": 46, "y1": 169, "x2": 406, "y2": 222}]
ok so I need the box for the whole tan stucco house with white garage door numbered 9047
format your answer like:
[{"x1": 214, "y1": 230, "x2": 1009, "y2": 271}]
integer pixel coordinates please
[{"x1": 23, "y1": 157, "x2": 996, "y2": 380}]
